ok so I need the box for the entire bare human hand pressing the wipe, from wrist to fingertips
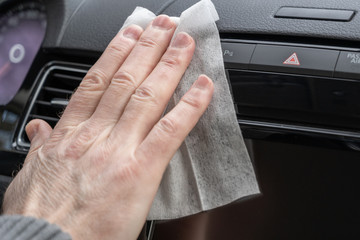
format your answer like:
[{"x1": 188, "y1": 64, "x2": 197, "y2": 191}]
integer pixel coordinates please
[{"x1": 3, "y1": 16, "x2": 213, "y2": 239}]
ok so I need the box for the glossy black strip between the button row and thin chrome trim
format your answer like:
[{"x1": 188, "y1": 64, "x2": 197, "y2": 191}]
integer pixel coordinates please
[{"x1": 229, "y1": 70, "x2": 360, "y2": 132}]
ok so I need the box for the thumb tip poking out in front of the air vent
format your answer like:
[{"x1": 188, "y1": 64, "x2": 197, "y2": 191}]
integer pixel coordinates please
[{"x1": 25, "y1": 119, "x2": 52, "y2": 153}]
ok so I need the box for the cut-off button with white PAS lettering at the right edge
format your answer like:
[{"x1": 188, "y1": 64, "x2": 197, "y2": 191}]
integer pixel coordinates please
[{"x1": 334, "y1": 52, "x2": 360, "y2": 79}]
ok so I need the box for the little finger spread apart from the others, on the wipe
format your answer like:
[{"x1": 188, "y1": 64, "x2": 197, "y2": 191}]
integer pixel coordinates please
[{"x1": 135, "y1": 75, "x2": 214, "y2": 172}]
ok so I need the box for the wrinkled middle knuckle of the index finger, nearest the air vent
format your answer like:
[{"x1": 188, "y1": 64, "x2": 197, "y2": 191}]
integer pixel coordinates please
[{"x1": 79, "y1": 68, "x2": 107, "y2": 90}]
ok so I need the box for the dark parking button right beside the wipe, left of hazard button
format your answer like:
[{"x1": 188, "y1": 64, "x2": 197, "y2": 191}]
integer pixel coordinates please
[{"x1": 221, "y1": 42, "x2": 256, "y2": 69}]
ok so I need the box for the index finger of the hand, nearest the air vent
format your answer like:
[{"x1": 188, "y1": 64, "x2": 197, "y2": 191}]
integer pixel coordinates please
[{"x1": 57, "y1": 25, "x2": 143, "y2": 127}]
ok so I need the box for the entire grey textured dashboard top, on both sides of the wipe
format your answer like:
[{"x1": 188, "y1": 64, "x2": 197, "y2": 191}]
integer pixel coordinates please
[{"x1": 44, "y1": 0, "x2": 360, "y2": 52}]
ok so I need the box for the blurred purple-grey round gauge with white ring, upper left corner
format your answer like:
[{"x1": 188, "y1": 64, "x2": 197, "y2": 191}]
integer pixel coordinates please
[{"x1": 0, "y1": 3, "x2": 46, "y2": 105}]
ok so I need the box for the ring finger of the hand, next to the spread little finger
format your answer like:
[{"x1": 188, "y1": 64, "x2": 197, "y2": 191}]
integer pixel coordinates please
[{"x1": 110, "y1": 33, "x2": 195, "y2": 144}]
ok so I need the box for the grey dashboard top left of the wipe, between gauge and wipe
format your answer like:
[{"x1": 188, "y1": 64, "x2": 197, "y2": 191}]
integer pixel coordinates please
[{"x1": 44, "y1": 0, "x2": 172, "y2": 52}]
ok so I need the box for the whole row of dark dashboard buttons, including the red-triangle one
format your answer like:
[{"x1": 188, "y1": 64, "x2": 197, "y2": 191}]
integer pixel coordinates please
[{"x1": 221, "y1": 42, "x2": 360, "y2": 80}]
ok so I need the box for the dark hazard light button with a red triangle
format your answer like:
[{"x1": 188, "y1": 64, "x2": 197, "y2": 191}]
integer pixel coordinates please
[{"x1": 249, "y1": 45, "x2": 340, "y2": 77}]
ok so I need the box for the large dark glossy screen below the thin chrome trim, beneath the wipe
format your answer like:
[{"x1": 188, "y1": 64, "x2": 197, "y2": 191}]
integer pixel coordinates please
[{"x1": 153, "y1": 141, "x2": 360, "y2": 240}]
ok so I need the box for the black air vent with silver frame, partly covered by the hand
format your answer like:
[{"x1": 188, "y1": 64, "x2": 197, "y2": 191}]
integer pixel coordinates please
[{"x1": 17, "y1": 63, "x2": 89, "y2": 150}]
